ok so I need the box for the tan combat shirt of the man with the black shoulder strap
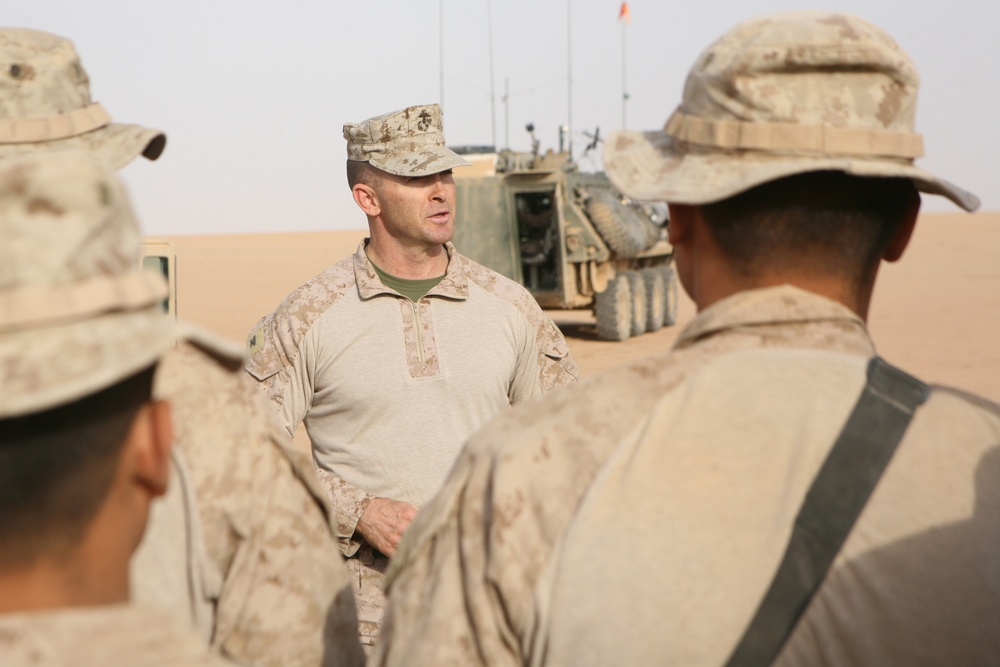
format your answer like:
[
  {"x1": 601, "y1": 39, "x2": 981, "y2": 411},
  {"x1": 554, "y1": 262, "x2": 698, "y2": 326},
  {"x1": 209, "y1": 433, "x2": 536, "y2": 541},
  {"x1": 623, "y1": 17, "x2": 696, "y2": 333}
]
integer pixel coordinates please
[{"x1": 370, "y1": 286, "x2": 1000, "y2": 667}]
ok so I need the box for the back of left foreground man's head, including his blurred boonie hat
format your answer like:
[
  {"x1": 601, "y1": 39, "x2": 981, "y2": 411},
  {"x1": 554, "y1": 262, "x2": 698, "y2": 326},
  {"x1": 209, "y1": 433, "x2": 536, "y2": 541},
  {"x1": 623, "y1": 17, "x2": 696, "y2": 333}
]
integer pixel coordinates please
[{"x1": 0, "y1": 151, "x2": 175, "y2": 566}]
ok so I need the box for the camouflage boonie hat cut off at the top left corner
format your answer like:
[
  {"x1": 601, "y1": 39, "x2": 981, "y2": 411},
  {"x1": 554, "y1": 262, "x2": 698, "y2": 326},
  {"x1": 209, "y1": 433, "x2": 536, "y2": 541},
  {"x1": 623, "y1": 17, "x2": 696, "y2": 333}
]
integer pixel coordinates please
[{"x1": 0, "y1": 28, "x2": 167, "y2": 169}]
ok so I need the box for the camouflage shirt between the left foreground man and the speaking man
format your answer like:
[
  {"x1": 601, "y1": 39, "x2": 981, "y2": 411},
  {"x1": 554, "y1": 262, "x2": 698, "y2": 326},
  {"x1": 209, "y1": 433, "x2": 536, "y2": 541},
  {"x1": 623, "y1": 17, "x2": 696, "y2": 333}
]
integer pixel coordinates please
[{"x1": 131, "y1": 336, "x2": 364, "y2": 665}]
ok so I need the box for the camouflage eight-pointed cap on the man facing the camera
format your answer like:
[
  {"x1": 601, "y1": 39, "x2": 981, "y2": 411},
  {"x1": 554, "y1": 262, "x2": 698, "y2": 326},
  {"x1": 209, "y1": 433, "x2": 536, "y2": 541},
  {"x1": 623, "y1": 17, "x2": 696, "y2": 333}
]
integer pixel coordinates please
[{"x1": 344, "y1": 104, "x2": 469, "y2": 176}]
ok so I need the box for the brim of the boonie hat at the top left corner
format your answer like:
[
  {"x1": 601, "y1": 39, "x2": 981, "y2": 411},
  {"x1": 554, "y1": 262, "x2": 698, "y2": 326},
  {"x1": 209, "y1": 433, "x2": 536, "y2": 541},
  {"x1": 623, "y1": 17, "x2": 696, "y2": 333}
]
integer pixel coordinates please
[{"x1": 0, "y1": 123, "x2": 167, "y2": 169}]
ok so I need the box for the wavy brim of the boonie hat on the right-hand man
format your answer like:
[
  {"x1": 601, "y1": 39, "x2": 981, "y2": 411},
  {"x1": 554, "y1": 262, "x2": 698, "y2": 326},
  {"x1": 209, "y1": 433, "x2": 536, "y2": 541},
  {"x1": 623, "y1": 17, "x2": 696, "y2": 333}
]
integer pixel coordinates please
[{"x1": 604, "y1": 131, "x2": 979, "y2": 211}]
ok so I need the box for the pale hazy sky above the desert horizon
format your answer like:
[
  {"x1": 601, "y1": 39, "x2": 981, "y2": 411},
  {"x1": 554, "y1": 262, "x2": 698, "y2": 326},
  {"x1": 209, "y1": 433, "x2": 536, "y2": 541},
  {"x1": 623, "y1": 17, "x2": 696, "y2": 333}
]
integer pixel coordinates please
[{"x1": 7, "y1": 0, "x2": 1000, "y2": 235}]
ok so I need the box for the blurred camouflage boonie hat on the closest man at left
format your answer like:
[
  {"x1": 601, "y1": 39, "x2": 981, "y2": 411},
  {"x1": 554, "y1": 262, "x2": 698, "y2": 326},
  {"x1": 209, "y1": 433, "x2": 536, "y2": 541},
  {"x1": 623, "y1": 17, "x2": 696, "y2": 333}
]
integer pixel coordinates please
[{"x1": 0, "y1": 151, "x2": 177, "y2": 418}]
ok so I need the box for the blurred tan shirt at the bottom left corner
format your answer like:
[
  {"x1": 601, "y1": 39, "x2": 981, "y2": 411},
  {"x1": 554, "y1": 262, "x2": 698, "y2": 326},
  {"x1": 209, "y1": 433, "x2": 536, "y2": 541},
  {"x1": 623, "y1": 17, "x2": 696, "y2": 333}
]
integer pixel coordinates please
[{"x1": 0, "y1": 604, "x2": 236, "y2": 667}]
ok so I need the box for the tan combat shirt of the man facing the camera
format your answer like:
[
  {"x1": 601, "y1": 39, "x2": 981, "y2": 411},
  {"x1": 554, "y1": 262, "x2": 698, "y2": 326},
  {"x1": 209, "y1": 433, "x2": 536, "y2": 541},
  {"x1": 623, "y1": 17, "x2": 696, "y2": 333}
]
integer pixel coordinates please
[{"x1": 246, "y1": 241, "x2": 577, "y2": 555}]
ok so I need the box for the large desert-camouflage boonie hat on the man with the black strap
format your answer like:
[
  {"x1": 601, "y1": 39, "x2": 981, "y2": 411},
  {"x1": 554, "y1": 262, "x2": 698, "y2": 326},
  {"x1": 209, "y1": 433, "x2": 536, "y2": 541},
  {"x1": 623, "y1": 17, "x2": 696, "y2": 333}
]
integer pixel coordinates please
[{"x1": 604, "y1": 12, "x2": 979, "y2": 211}]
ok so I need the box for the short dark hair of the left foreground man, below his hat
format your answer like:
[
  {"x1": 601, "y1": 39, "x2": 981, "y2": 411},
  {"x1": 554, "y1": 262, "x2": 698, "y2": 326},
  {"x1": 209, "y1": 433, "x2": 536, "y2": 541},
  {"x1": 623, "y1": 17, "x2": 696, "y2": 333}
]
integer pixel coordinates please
[{"x1": 0, "y1": 365, "x2": 156, "y2": 569}]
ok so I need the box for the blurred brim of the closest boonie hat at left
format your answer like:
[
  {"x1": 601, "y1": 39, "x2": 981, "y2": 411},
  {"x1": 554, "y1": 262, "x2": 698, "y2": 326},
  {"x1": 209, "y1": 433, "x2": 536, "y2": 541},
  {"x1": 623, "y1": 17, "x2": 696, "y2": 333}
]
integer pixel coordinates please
[{"x1": 0, "y1": 303, "x2": 176, "y2": 418}]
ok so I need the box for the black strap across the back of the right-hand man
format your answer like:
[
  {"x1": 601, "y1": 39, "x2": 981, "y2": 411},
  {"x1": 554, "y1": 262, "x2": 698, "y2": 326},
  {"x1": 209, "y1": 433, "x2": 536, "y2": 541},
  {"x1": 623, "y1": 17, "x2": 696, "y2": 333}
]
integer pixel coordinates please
[{"x1": 726, "y1": 357, "x2": 930, "y2": 667}]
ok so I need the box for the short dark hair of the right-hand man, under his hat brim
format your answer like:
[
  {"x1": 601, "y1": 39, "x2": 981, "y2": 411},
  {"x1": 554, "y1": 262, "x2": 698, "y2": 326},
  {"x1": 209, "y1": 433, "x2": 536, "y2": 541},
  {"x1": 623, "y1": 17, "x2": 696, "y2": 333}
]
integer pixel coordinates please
[{"x1": 702, "y1": 171, "x2": 919, "y2": 287}]
